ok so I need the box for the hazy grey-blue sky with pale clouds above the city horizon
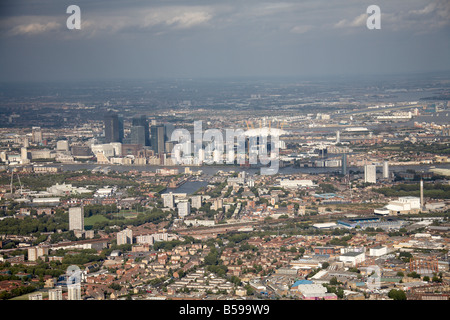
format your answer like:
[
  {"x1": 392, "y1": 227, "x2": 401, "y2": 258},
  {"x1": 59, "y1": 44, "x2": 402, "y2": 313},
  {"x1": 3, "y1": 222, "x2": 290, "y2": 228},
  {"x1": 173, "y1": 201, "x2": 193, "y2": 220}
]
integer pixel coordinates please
[{"x1": 0, "y1": 0, "x2": 450, "y2": 82}]
